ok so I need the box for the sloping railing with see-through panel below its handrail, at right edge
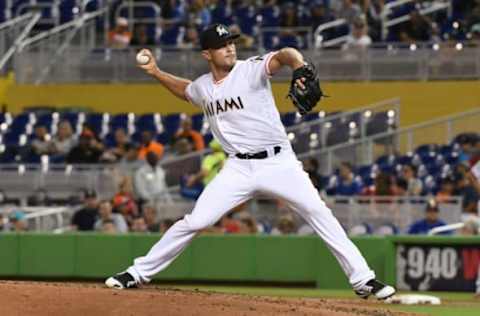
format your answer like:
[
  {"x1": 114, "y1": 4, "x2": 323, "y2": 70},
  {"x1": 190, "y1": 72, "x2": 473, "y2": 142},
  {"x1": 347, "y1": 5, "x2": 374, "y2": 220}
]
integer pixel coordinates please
[{"x1": 298, "y1": 109, "x2": 480, "y2": 174}]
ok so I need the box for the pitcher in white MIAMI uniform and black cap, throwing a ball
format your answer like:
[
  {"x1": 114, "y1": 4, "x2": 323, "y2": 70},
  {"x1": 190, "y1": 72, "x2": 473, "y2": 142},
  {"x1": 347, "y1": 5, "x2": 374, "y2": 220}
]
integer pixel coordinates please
[{"x1": 105, "y1": 24, "x2": 395, "y2": 299}]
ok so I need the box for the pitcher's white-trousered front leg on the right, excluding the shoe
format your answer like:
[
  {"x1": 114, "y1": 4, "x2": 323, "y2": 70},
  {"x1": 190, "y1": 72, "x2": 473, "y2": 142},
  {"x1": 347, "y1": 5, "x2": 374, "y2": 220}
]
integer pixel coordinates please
[{"x1": 258, "y1": 158, "x2": 375, "y2": 289}]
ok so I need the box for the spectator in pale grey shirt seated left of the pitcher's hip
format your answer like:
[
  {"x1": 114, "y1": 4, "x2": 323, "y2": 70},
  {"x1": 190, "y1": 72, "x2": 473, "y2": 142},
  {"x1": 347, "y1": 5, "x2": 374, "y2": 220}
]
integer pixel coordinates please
[{"x1": 135, "y1": 151, "x2": 170, "y2": 202}]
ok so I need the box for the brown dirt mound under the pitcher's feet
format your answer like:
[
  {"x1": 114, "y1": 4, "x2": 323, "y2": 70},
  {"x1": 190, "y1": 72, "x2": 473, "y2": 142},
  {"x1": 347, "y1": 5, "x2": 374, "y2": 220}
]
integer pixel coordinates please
[{"x1": 0, "y1": 281, "x2": 411, "y2": 316}]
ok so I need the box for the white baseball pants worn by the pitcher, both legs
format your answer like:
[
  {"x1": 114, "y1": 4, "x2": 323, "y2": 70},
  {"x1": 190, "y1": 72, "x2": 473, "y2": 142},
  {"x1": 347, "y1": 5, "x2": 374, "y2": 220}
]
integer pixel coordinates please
[{"x1": 127, "y1": 150, "x2": 375, "y2": 289}]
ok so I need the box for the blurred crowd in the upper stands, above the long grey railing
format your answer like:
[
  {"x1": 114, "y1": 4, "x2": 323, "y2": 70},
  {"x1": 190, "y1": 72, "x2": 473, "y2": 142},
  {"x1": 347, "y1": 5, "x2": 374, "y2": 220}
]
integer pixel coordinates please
[{"x1": 109, "y1": 0, "x2": 480, "y2": 49}]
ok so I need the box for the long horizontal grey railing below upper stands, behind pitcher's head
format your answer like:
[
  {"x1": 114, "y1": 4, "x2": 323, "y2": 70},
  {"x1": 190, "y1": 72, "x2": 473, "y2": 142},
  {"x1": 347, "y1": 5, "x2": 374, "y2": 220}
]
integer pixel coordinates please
[{"x1": 15, "y1": 39, "x2": 480, "y2": 84}]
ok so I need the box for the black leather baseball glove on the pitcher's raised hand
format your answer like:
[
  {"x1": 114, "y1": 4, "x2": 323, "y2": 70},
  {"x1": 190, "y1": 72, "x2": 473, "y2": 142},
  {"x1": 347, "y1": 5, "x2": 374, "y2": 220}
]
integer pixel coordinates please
[{"x1": 287, "y1": 63, "x2": 326, "y2": 115}]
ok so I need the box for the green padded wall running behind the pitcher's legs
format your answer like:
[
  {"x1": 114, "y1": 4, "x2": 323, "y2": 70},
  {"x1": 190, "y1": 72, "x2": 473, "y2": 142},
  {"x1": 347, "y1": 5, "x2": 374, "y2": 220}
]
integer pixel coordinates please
[{"x1": 0, "y1": 233, "x2": 479, "y2": 288}]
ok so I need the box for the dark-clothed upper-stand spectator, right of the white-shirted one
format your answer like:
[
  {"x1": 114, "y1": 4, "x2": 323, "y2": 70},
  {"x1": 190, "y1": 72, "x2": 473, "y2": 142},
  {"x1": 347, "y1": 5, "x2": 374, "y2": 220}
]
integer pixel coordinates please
[{"x1": 399, "y1": 9, "x2": 432, "y2": 43}]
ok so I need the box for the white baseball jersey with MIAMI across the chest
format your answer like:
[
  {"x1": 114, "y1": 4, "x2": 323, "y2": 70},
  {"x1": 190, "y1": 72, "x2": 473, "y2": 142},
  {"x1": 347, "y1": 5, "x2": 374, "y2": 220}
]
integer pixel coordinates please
[{"x1": 186, "y1": 52, "x2": 290, "y2": 155}]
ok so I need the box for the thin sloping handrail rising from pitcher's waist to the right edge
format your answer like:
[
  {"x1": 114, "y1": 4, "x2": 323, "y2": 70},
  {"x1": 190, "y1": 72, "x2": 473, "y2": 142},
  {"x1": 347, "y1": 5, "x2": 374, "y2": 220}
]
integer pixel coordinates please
[{"x1": 298, "y1": 109, "x2": 480, "y2": 158}]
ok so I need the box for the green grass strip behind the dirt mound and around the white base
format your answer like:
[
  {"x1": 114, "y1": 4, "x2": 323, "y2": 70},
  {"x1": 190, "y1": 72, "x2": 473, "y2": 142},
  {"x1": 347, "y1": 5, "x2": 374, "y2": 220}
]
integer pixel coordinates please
[{"x1": 163, "y1": 285, "x2": 480, "y2": 316}]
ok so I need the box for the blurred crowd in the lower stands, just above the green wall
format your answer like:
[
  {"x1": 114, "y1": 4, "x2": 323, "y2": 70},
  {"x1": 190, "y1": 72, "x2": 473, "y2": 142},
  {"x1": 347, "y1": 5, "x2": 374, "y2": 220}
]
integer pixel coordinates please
[{"x1": 0, "y1": 126, "x2": 480, "y2": 235}]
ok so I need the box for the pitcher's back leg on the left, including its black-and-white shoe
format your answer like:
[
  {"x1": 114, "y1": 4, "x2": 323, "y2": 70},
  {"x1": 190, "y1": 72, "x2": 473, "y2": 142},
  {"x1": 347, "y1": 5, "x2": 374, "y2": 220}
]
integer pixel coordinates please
[{"x1": 105, "y1": 161, "x2": 252, "y2": 288}]
